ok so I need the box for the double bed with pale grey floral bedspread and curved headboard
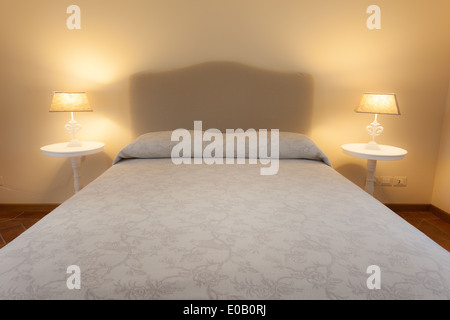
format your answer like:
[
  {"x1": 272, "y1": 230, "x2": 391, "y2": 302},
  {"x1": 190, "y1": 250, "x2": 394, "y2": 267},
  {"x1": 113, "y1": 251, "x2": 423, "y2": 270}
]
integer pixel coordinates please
[{"x1": 0, "y1": 63, "x2": 450, "y2": 300}]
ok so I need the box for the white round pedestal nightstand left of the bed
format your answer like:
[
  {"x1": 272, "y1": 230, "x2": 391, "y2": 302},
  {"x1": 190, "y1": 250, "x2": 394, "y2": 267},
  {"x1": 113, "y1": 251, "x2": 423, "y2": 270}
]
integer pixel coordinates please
[{"x1": 41, "y1": 141, "x2": 105, "y2": 192}]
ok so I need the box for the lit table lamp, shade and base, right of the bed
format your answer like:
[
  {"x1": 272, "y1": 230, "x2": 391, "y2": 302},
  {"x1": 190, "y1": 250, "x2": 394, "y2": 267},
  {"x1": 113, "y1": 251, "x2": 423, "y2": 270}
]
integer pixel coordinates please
[{"x1": 355, "y1": 93, "x2": 400, "y2": 150}]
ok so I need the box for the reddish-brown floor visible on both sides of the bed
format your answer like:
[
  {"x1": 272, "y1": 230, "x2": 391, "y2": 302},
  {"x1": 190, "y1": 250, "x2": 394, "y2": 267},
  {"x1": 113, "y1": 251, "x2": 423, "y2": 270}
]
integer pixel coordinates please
[{"x1": 0, "y1": 208, "x2": 450, "y2": 251}]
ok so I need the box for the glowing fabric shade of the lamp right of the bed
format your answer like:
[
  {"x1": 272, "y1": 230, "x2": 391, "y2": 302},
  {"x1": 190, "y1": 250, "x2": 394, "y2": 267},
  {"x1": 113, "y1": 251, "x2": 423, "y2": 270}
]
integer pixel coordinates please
[{"x1": 355, "y1": 93, "x2": 400, "y2": 115}]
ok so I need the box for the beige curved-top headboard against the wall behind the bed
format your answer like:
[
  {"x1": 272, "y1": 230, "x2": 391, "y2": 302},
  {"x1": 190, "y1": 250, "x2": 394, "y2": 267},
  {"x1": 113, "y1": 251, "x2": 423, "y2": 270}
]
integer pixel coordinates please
[{"x1": 130, "y1": 62, "x2": 313, "y2": 136}]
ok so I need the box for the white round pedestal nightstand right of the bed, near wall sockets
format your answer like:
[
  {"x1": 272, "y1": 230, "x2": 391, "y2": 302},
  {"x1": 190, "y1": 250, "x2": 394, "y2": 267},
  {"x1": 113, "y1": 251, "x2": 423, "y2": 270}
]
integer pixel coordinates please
[{"x1": 341, "y1": 143, "x2": 408, "y2": 194}]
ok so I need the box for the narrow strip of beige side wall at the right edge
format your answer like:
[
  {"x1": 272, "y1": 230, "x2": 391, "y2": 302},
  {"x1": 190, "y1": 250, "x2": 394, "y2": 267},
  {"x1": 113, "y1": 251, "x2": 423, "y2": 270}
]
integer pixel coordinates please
[{"x1": 431, "y1": 83, "x2": 450, "y2": 212}]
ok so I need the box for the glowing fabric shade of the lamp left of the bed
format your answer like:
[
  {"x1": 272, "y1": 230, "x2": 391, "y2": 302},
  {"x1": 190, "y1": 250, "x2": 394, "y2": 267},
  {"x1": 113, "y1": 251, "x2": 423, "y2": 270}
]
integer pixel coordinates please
[{"x1": 50, "y1": 91, "x2": 92, "y2": 112}]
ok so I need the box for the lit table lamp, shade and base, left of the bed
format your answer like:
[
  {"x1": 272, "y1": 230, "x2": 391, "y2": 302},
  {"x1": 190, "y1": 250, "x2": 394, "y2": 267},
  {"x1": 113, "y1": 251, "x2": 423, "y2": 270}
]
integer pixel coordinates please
[{"x1": 50, "y1": 91, "x2": 92, "y2": 147}]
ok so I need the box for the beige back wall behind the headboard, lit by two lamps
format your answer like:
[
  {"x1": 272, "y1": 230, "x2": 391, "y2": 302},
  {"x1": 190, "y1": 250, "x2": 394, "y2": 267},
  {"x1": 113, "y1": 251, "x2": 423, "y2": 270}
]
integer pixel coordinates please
[{"x1": 0, "y1": 0, "x2": 450, "y2": 203}]
